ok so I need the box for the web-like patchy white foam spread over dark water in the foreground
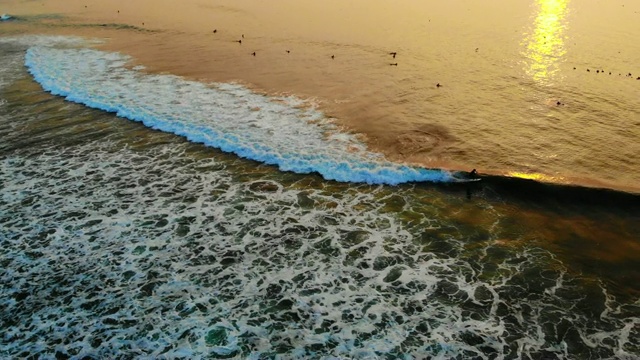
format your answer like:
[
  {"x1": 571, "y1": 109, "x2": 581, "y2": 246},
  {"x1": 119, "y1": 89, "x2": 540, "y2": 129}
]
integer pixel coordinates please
[{"x1": 0, "y1": 137, "x2": 638, "y2": 359}]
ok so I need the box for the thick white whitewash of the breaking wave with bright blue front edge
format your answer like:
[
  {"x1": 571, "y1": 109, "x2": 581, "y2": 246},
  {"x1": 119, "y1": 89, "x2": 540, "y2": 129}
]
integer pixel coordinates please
[{"x1": 25, "y1": 46, "x2": 454, "y2": 185}]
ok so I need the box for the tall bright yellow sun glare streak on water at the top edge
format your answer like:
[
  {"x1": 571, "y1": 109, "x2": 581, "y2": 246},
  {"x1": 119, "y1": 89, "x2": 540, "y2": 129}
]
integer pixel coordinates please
[{"x1": 524, "y1": 0, "x2": 569, "y2": 82}]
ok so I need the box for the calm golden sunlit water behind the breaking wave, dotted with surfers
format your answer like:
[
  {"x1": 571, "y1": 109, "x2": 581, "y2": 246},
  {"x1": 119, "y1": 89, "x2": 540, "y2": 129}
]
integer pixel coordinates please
[{"x1": 3, "y1": 0, "x2": 640, "y2": 193}]
